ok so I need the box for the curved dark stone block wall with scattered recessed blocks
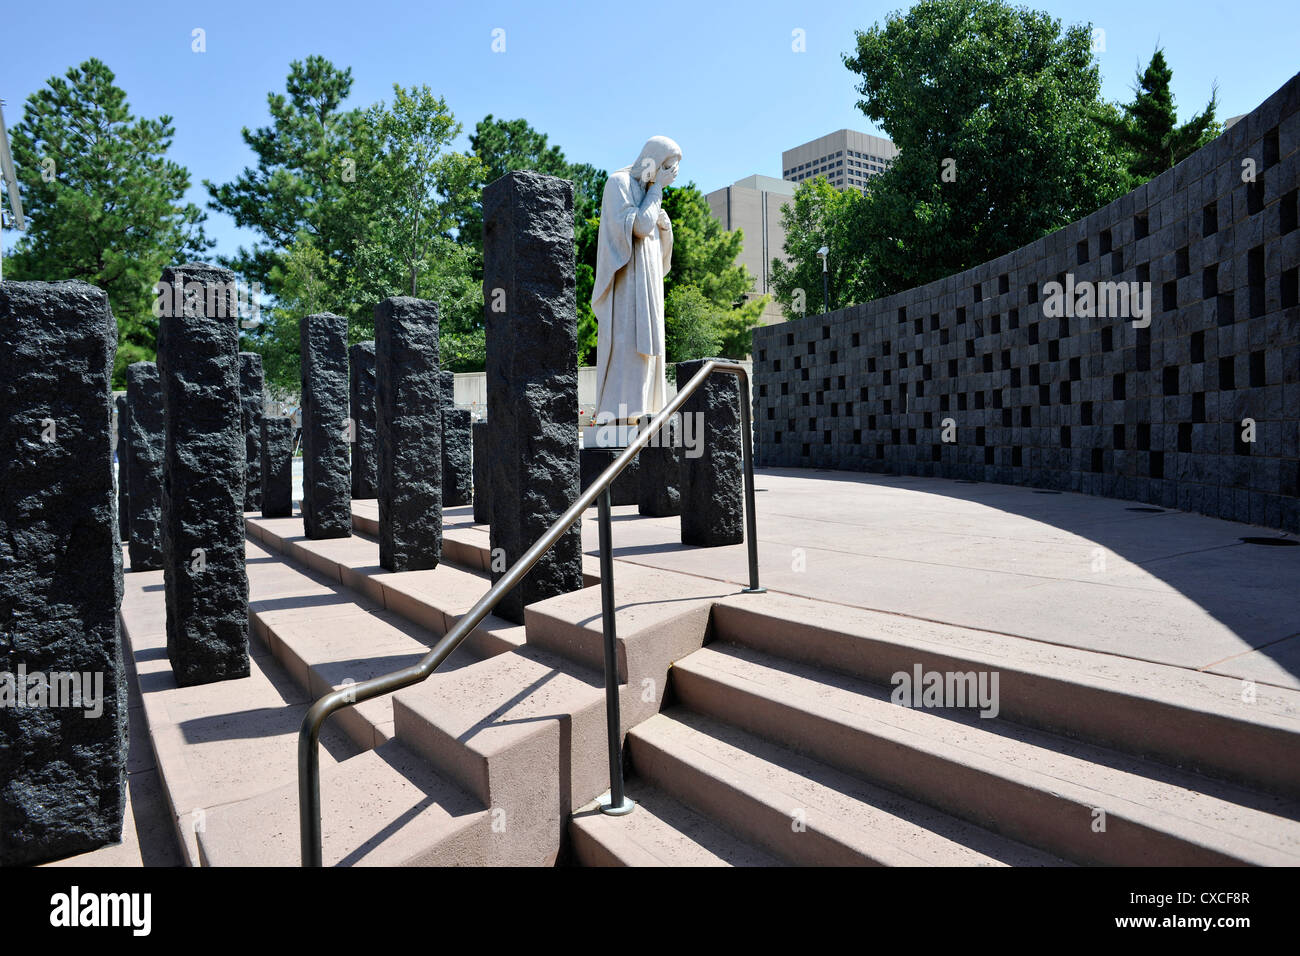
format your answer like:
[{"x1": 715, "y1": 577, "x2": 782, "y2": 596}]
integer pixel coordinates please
[{"x1": 754, "y1": 75, "x2": 1300, "y2": 531}]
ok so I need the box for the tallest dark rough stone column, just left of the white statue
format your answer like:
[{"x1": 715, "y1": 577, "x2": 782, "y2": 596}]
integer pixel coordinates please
[{"x1": 484, "y1": 172, "x2": 582, "y2": 623}]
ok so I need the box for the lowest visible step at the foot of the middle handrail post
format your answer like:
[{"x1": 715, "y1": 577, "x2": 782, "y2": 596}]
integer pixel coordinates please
[{"x1": 569, "y1": 780, "x2": 784, "y2": 866}]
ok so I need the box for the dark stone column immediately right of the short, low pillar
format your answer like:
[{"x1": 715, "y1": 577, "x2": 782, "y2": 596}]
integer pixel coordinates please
[{"x1": 302, "y1": 312, "x2": 355, "y2": 538}]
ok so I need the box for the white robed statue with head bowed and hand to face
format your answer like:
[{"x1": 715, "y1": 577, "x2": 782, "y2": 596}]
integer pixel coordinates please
[{"x1": 592, "y1": 137, "x2": 681, "y2": 425}]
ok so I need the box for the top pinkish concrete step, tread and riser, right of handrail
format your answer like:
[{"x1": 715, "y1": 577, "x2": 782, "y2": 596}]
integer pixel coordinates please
[{"x1": 712, "y1": 593, "x2": 1300, "y2": 797}]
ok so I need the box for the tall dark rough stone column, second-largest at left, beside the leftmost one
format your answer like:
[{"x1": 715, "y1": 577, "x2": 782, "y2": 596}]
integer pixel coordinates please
[{"x1": 157, "y1": 263, "x2": 248, "y2": 687}]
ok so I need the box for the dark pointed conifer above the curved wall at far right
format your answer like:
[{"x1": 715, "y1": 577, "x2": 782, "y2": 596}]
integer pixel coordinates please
[{"x1": 1102, "y1": 48, "x2": 1223, "y2": 189}]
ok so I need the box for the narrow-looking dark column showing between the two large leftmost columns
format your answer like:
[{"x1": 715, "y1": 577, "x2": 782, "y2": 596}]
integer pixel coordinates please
[{"x1": 126, "y1": 362, "x2": 166, "y2": 571}]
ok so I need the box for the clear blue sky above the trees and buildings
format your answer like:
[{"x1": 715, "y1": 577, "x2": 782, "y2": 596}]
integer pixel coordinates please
[{"x1": 0, "y1": 0, "x2": 1300, "y2": 260}]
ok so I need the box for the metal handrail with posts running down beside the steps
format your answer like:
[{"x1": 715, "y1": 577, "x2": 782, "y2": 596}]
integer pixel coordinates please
[{"x1": 298, "y1": 362, "x2": 764, "y2": 866}]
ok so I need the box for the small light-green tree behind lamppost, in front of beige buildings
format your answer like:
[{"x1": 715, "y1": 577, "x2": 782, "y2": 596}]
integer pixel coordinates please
[{"x1": 772, "y1": 176, "x2": 865, "y2": 319}]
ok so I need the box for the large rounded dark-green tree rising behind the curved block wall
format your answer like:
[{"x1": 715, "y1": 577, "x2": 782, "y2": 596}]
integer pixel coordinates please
[{"x1": 832, "y1": 0, "x2": 1125, "y2": 304}]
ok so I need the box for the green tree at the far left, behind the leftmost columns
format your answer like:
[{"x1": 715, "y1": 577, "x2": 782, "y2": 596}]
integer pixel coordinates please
[{"x1": 7, "y1": 59, "x2": 213, "y2": 385}]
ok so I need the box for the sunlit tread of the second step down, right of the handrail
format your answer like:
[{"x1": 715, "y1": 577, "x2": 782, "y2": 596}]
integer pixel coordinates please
[{"x1": 675, "y1": 643, "x2": 1300, "y2": 865}]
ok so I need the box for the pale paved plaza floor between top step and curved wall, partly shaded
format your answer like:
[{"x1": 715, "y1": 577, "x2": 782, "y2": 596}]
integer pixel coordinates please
[{"x1": 582, "y1": 468, "x2": 1300, "y2": 688}]
